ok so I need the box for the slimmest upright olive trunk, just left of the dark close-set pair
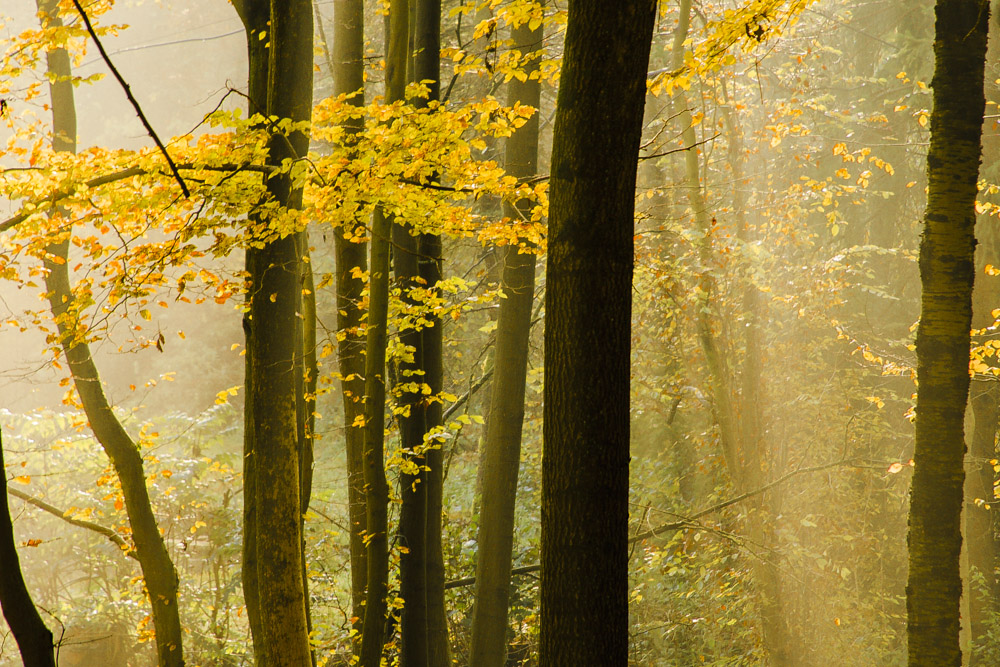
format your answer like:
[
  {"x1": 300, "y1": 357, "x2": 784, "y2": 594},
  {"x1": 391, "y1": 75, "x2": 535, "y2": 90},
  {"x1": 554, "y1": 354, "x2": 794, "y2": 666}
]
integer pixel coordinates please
[{"x1": 360, "y1": 0, "x2": 409, "y2": 667}]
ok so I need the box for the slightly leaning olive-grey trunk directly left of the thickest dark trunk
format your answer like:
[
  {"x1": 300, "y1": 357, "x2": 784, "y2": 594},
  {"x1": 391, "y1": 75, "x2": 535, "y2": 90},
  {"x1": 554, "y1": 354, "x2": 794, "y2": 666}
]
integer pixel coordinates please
[{"x1": 470, "y1": 6, "x2": 543, "y2": 667}]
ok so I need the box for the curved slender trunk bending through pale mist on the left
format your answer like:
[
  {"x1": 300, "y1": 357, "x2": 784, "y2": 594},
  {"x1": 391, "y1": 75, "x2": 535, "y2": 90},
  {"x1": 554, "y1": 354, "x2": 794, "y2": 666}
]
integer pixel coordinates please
[{"x1": 37, "y1": 2, "x2": 184, "y2": 667}]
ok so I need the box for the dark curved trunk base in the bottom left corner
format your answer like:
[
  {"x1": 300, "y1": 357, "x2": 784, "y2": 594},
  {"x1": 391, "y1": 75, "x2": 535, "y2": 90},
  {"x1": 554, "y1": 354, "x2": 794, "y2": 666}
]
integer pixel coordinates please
[{"x1": 0, "y1": 428, "x2": 55, "y2": 667}]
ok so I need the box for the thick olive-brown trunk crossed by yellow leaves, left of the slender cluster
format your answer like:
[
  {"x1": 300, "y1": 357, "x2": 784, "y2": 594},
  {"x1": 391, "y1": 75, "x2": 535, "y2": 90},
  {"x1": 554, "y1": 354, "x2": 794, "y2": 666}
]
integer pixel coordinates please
[{"x1": 247, "y1": 0, "x2": 313, "y2": 667}]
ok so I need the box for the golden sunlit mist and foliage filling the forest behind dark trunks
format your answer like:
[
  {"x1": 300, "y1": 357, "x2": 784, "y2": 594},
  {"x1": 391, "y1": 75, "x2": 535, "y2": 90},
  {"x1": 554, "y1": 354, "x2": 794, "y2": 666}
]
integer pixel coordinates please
[{"x1": 0, "y1": 0, "x2": 1000, "y2": 667}]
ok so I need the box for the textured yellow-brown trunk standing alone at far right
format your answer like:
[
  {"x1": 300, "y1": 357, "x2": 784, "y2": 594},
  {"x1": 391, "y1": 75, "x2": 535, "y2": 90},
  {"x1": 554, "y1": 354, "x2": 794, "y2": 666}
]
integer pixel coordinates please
[{"x1": 906, "y1": 0, "x2": 989, "y2": 667}]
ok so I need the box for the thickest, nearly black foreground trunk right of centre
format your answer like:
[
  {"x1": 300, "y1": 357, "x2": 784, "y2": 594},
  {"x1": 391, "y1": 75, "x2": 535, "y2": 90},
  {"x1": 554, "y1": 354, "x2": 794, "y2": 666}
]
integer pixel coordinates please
[{"x1": 539, "y1": 0, "x2": 656, "y2": 667}]
